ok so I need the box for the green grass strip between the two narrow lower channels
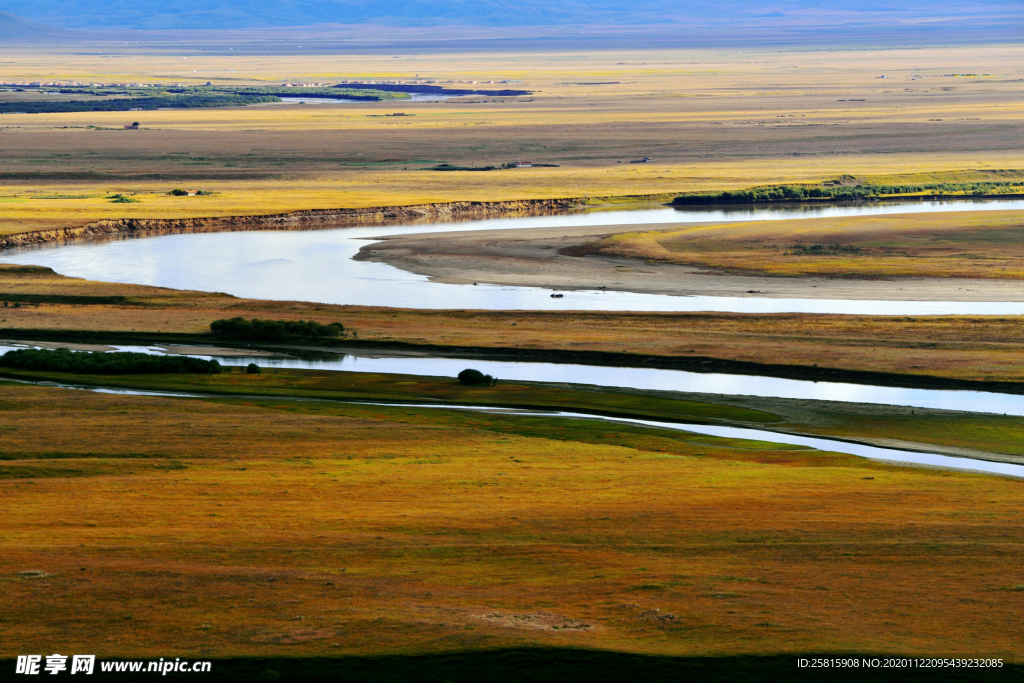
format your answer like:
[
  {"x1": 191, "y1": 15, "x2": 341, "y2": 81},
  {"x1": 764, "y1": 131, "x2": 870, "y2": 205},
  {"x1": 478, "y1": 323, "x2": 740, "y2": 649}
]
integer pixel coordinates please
[{"x1": 6, "y1": 368, "x2": 1024, "y2": 464}]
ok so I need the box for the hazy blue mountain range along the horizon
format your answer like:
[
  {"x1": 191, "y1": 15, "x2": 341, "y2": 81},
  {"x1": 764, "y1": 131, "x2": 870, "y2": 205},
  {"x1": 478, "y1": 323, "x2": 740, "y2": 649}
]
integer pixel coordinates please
[{"x1": 0, "y1": 0, "x2": 1024, "y2": 30}]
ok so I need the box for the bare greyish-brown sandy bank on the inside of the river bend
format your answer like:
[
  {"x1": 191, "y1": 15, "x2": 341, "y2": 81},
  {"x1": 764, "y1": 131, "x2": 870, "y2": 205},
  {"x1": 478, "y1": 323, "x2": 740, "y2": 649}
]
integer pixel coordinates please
[{"x1": 356, "y1": 224, "x2": 1024, "y2": 301}]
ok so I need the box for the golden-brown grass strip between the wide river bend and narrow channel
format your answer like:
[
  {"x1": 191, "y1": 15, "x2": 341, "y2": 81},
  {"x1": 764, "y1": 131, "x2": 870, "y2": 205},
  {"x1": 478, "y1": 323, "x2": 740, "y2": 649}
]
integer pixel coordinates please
[{"x1": 6, "y1": 265, "x2": 1024, "y2": 382}]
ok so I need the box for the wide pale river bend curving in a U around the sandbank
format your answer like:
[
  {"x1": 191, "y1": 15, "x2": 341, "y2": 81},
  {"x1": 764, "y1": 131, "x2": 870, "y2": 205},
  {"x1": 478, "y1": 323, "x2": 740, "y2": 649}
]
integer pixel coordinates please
[{"x1": 6, "y1": 200, "x2": 1024, "y2": 315}]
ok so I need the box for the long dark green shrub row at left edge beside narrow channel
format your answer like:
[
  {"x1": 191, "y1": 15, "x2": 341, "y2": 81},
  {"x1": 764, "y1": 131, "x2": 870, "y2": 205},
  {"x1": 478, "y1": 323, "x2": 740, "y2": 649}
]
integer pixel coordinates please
[{"x1": 0, "y1": 348, "x2": 221, "y2": 375}]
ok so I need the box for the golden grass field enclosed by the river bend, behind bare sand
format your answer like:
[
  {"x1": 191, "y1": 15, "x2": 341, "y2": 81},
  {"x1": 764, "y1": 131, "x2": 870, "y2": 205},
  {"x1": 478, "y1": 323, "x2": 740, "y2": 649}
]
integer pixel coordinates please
[{"x1": 573, "y1": 211, "x2": 1024, "y2": 280}]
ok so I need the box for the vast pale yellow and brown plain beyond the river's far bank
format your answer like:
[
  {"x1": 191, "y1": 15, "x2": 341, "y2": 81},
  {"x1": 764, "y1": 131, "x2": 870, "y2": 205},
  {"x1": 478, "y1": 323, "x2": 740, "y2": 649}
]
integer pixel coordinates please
[{"x1": 0, "y1": 45, "x2": 1024, "y2": 233}]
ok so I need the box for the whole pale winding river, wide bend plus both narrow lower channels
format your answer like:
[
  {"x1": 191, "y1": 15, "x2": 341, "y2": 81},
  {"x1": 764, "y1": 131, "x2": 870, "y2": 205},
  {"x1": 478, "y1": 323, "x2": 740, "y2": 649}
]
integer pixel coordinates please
[{"x1": 6, "y1": 200, "x2": 1024, "y2": 477}]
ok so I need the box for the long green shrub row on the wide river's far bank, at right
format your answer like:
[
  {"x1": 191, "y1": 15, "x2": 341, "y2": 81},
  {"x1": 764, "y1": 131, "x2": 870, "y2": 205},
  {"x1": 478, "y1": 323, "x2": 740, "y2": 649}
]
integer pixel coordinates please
[{"x1": 672, "y1": 181, "x2": 1024, "y2": 205}]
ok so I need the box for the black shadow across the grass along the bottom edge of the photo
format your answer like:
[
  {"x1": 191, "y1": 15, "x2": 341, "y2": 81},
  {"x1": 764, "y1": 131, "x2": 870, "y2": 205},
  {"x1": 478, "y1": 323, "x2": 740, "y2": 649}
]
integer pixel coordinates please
[{"x1": 0, "y1": 648, "x2": 1024, "y2": 683}]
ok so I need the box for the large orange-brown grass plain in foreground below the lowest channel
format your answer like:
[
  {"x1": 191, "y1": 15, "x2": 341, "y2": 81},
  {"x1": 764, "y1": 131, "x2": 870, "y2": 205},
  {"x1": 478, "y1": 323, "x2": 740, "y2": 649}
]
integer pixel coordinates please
[{"x1": 0, "y1": 375, "x2": 1024, "y2": 658}]
